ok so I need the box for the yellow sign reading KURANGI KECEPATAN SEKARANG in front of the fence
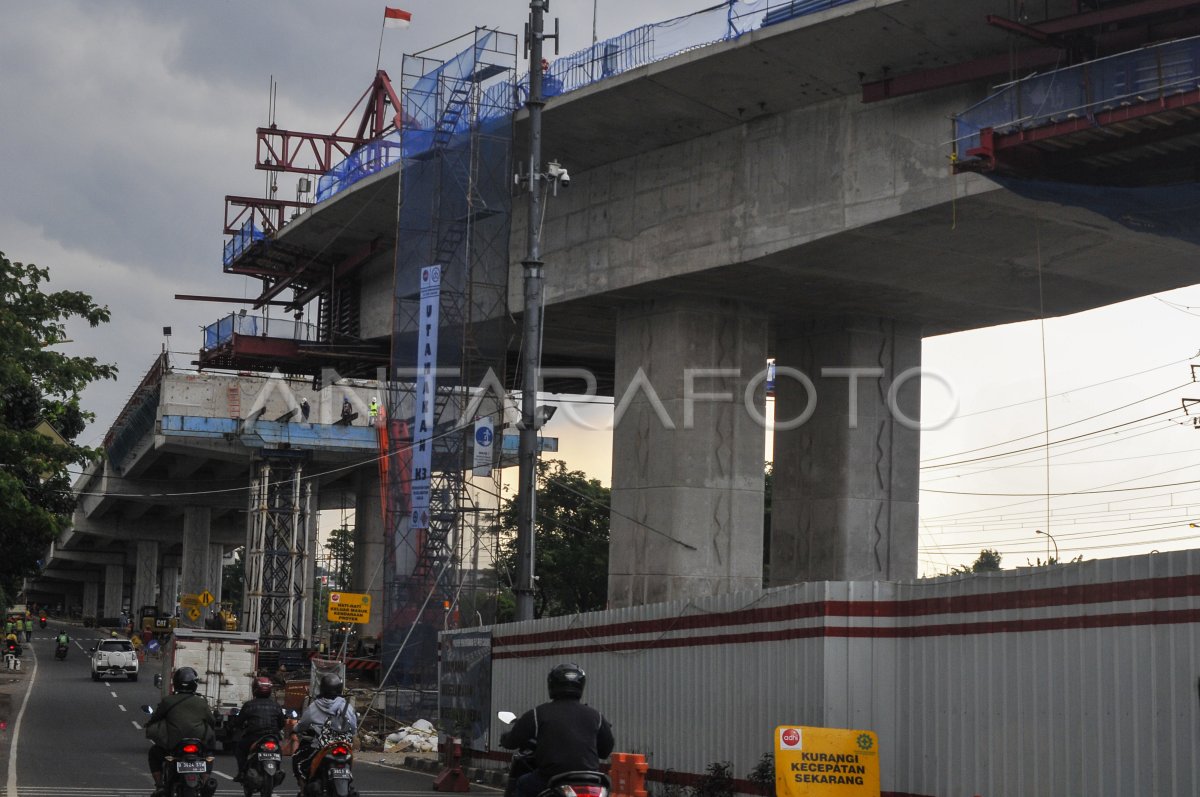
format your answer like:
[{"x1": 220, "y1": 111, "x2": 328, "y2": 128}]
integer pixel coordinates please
[{"x1": 775, "y1": 725, "x2": 880, "y2": 797}]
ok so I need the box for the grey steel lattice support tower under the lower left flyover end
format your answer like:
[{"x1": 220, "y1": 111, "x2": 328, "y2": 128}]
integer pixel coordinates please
[{"x1": 242, "y1": 453, "x2": 316, "y2": 649}]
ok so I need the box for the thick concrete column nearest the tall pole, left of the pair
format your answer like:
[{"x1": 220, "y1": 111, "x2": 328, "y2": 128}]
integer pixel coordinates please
[{"x1": 608, "y1": 298, "x2": 767, "y2": 606}]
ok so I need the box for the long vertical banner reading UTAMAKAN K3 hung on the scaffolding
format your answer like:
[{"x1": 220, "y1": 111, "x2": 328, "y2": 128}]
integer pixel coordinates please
[{"x1": 410, "y1": 265, "x2": 442, "y2": 528}]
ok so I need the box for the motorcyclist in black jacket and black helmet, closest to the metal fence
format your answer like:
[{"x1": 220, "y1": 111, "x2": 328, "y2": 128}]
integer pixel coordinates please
[{"x1": 500, "y1": 664, "x2": 613, "y2": 797}]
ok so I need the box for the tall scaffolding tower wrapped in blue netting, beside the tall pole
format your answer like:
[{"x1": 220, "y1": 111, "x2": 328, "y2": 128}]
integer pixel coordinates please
[{"x1": 383, "y1": 28, "x2": 517, "y2": 708}]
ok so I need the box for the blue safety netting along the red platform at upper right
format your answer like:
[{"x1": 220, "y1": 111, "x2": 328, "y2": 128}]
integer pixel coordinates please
[{"x1": 954, "y1": 37, "x2": 1200, "y2": 160}]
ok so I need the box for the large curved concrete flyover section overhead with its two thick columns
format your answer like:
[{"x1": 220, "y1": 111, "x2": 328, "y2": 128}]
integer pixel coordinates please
[{"x1": 223, "y1": 0, "x2": 1198, "y2": 605}]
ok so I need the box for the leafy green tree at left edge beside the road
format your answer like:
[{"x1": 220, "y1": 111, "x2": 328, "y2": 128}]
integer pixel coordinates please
[{"x1": 0, "y1": 252, "x2": 116, "y2": 603}]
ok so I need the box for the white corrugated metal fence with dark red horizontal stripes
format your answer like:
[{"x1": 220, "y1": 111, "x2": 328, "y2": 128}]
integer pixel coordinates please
[{"x1": 444, "y1": 551, "x2": 1200, "y2": 797}]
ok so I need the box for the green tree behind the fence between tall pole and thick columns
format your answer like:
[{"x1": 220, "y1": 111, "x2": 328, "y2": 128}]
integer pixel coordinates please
[{"x1": 497, "y1": 460, "x2": 612, "y2": 622}]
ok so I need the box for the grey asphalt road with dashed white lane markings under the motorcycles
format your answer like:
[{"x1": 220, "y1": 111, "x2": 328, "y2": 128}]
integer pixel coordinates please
[{"x1": 0, "y1": 624, "x2": 472, "y2": 797}]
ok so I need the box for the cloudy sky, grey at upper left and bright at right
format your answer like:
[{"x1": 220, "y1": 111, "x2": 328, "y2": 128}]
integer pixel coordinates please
[{"x1": 9, "y1": 0, "x2": 1200, "y2": 573}]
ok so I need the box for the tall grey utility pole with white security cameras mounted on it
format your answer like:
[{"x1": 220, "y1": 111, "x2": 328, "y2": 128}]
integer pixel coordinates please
[{"x1": 514, "y1": 0, "x2": 558, "y2": 621}]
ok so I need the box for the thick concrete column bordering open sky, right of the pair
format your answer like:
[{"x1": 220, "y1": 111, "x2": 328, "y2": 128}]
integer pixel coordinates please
[{"x1": 769, "y1": 318, "x2": 920, "y2": 587}]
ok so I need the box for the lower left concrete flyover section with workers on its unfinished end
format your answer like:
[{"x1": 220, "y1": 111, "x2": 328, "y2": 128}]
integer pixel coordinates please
[{"x1": 28, "y1": 370, "x2": 393, "y2": 634}]
